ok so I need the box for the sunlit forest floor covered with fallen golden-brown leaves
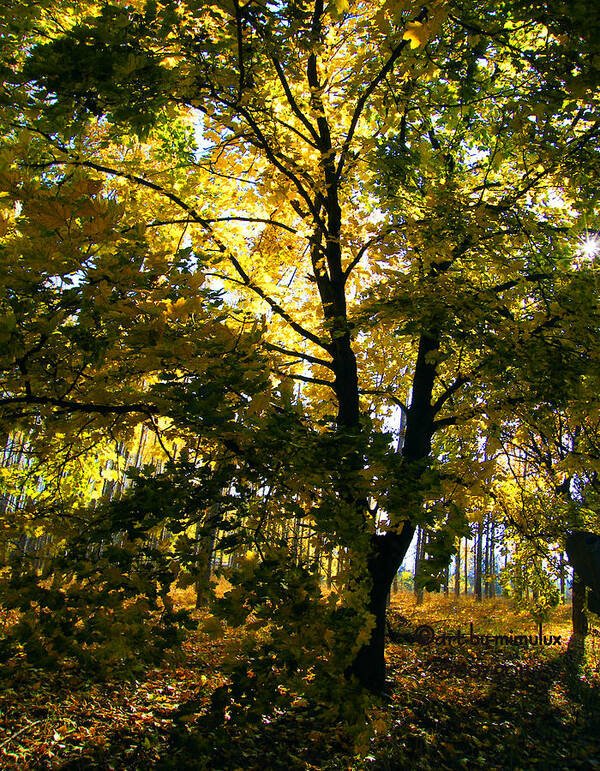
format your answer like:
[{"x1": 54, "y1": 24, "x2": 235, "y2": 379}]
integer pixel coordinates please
[{"x1": 0, "y1": 593, "x2": 600, "y2": 771}]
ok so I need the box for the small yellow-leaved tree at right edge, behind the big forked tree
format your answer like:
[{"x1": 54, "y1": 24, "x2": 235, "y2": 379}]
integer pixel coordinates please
[{"x1": 492, "y1": 373, "x2": 598, "y2": 634}]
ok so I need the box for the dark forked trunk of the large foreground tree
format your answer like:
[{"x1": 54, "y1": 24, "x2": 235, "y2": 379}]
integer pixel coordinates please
[{"x1": 306, "y1": 63, "x2": 442, "y2": 690}]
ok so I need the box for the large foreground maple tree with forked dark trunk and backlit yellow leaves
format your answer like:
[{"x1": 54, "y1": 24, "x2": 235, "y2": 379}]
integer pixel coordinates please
[{"x1": 0, "y1": 0, "x2": 600, "y2": 689}]
